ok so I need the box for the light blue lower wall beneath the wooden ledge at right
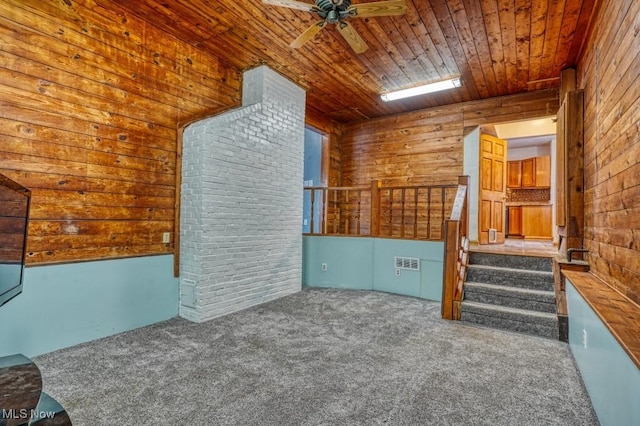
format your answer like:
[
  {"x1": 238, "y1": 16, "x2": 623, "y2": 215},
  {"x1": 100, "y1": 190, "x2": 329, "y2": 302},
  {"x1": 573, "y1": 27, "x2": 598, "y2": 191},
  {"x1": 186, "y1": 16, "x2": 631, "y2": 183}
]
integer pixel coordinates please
[{"x1": 565, "y1": 280, "x2": 640, "y2": 426}]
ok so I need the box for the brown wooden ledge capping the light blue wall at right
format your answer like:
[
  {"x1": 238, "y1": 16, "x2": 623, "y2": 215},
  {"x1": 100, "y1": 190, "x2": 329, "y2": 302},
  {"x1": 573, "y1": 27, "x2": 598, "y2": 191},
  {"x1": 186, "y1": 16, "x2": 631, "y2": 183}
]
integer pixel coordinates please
[{"x1": 562, "y1": 270, "x2": 640, "y2": 368}]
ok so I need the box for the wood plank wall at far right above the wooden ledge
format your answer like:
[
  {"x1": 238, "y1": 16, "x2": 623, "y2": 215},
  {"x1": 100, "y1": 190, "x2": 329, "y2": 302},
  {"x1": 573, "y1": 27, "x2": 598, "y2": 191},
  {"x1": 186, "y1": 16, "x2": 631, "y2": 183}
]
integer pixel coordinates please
[{"x1": 578, "y1": 0, "x2": 640, "y2": 303}]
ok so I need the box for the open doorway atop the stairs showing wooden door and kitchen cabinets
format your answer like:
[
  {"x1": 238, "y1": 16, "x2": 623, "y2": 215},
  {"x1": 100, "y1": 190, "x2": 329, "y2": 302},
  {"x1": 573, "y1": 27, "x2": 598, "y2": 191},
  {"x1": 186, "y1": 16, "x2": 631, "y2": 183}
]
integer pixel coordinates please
[{"x1": 463, "y1": 116, "x2": 558, "y2": 253}]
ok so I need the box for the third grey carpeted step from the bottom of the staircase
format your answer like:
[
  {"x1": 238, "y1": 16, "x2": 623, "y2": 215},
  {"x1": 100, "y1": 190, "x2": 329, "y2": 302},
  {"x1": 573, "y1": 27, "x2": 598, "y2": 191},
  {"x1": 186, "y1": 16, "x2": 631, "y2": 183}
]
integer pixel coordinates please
[{"x1": 466, "y1": 265, "x2": 554, "y2": 291}]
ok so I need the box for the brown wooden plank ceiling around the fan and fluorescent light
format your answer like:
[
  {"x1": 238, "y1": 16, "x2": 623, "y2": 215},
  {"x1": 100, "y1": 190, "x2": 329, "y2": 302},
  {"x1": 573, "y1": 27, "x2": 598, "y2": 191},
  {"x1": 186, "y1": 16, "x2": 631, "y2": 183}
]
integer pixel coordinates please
[{"x1": 96, "y1": 0, "x2": 597, "y2": 123}]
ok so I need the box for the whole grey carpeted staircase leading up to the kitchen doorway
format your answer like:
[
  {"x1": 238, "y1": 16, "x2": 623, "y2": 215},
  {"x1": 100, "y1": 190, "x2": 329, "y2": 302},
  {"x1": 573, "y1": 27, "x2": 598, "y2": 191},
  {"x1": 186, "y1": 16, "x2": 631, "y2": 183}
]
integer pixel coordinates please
[{"x1": 460, "y1": 252, "x2": 558, "y2": 340}]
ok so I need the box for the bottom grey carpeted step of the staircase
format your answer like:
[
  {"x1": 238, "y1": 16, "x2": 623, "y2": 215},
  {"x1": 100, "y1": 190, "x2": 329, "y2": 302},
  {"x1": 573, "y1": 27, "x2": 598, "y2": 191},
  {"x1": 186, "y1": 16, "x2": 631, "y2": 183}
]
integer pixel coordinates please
[{"x1": 460, "y1": 301, "x2": 558, "y2": 340}]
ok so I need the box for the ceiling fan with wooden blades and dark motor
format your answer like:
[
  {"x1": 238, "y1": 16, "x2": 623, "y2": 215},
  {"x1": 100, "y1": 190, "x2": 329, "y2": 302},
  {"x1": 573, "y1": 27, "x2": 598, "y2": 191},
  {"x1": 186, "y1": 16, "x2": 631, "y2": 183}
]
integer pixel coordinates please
[{"x1": 262, "y1": 0, "x2": 407, "y2": 53}]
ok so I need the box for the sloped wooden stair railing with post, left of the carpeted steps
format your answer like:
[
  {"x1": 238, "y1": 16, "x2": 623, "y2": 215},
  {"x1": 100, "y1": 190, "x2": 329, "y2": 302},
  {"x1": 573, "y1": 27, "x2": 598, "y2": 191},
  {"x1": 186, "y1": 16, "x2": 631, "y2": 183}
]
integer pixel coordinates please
[{"x1": 442, "y1": 176, "x2": 469, "y2": 320}]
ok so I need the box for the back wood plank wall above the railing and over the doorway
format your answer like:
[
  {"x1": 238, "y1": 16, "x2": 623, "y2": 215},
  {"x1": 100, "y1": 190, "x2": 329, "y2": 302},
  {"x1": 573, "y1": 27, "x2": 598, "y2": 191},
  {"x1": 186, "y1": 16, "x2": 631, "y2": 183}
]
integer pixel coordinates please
[{"x1": 342, "y1": 90, "x2": 559, "y2": 186}]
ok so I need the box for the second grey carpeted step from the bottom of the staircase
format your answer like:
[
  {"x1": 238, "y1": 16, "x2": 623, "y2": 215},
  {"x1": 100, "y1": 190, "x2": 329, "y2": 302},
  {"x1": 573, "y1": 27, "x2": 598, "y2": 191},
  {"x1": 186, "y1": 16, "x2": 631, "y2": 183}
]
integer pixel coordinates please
[{"x1": 464, "y1": 282, "x2": 556, "y2": 313}]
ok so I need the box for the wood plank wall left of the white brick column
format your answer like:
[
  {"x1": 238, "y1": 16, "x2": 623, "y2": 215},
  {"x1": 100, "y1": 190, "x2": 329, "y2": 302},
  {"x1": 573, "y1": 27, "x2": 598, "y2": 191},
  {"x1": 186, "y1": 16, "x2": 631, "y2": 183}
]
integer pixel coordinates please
[{"x1": 0, "y1": 0, "x2": 241, "y2": 264}]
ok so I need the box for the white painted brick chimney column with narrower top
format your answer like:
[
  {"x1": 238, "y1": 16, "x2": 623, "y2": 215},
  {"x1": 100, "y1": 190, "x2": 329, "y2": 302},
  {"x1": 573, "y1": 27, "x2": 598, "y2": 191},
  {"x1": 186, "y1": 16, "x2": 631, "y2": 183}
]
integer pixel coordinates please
[{"x1": 180, "y1": 66, "x2": 306, "y2": 322}]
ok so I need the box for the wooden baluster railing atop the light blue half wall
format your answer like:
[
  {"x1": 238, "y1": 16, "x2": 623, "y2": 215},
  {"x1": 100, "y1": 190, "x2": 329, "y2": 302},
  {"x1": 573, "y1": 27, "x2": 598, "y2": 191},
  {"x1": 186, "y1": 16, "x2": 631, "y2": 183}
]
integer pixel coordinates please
[{"x1": 304, "y1": 180, "x2": 457, "y2": 241}]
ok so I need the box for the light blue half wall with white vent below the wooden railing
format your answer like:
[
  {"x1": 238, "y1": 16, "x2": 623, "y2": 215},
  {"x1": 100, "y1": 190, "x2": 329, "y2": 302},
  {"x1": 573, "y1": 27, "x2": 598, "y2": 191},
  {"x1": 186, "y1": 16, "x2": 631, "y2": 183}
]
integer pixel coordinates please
[{"x1": 302, "y1": 236, "x2": 444, "y2": 301}]
